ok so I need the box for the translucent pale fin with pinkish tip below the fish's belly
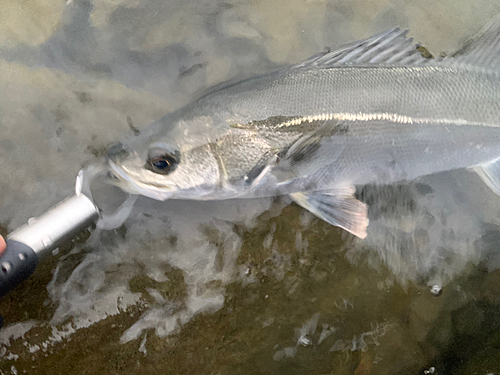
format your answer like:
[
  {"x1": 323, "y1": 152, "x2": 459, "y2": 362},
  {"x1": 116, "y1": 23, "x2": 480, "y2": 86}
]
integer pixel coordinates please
[{"x1": 290, "y1": 186, "x2": 368, "y2": 238}]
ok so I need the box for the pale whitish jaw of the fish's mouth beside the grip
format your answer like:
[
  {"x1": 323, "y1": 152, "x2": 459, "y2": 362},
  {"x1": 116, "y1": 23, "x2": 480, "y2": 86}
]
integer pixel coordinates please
[{"x1": 108, "y1": 159, "x2": 174, "y2": 201}]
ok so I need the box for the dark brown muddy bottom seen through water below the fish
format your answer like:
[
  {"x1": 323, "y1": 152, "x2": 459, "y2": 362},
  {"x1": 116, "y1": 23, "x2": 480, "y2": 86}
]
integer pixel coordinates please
[{"x1": 0, "y1": 205, "x2": 500, "y2": 374}]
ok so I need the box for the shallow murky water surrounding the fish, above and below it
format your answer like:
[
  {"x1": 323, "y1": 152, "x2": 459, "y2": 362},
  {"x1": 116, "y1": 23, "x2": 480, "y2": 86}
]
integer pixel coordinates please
[{"x1": 0, "y1": 0, "x2": 500, "y2": 375}]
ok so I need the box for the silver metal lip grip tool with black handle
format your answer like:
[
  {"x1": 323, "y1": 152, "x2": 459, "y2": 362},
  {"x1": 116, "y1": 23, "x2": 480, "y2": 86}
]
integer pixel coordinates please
[{"x1": 0, "y1": 170, "x2": 99, "y2": 296}]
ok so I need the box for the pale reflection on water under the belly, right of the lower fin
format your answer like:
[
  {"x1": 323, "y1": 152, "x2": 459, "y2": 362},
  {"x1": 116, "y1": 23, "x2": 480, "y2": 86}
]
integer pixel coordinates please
[{"x1": 349, "y1": 170, "x2": 500, "y2": 286}]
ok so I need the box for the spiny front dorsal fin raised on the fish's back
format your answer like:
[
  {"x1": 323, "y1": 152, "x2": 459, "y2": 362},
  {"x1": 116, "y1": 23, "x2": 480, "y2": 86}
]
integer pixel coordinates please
[{"x1": 292, "y1": 28, "x2": 429, "y2": 68}]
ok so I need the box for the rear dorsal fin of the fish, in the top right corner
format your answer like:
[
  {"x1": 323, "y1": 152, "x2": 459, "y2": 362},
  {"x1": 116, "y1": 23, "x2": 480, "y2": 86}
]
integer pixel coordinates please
[{"x1": 452, "y1": 17, "x2": 500, "y2": 70}]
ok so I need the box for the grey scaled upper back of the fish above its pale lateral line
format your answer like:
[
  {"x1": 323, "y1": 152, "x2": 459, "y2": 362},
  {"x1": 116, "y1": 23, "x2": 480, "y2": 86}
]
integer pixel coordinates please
[{"x1": 193, "y1": 66, "x2": 500, "y2": 126}]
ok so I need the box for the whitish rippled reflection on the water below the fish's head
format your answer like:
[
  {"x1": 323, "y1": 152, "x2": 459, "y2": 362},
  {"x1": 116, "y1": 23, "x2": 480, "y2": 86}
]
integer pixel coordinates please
[{"x1": 45, "y1": 199, "x2": 271, "y2": 342}]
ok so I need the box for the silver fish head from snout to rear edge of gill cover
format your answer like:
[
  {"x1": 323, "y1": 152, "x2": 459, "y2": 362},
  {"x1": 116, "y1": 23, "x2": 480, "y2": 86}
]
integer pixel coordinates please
[{"x1": 108, "y1": 108, "x2": 288, "y2": 200}]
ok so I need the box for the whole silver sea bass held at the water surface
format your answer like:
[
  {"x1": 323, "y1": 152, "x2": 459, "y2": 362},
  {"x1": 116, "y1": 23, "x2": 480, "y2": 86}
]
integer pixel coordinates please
[{"x1": 108, "y1": 19, "x2": 500, "y2": 238}]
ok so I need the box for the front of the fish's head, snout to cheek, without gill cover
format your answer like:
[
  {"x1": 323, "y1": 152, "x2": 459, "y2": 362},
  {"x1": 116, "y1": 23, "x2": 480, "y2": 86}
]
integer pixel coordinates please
[{"x1": 107, "y1": 114, "x2": 233, "y2": 200}]
